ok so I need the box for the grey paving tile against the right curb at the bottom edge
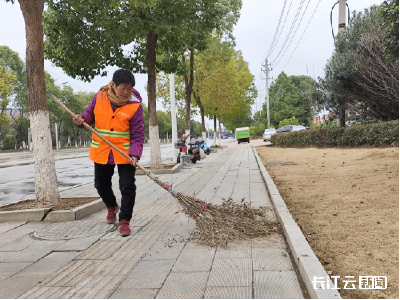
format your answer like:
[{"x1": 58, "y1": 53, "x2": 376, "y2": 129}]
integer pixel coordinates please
[{"x1": 254, "y1": 271, "x2": 304, "y2": 299}]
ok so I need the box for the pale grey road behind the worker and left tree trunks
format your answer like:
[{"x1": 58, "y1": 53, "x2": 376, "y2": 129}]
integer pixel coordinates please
[{"x1": 0, "y1": 145, "x2": 172, "y2": 205}]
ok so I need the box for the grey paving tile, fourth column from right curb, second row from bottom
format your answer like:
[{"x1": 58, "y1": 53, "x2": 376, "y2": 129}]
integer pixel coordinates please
[{"x1": 118, "y1": 260, "x2": 175, "y2": 289}]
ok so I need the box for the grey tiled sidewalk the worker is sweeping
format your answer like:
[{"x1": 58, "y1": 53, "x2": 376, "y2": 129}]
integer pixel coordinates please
[{"x1": 0, "y1": 144, "x2": 304, "y2": 299}]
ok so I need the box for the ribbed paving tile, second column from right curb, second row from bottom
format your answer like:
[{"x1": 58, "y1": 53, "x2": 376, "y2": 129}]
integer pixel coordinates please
[{"x1": 207, "y1": 258, "x2": 253, "y2": 287}]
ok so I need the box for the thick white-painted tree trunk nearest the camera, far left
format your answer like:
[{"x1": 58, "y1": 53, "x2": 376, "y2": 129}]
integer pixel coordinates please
[{"x1": 19, "y1": 0, "x2": 60, "y2": 204}]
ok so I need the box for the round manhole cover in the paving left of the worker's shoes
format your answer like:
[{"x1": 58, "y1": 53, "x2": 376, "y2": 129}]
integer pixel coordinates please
[{"x1": 33, "y1": 220, "x2": 115, "y2": 241}]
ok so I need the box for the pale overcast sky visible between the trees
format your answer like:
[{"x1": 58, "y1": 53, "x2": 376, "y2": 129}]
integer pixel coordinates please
[{"x1": 0, "y1": 0, "x2": 383, "y2": 128}]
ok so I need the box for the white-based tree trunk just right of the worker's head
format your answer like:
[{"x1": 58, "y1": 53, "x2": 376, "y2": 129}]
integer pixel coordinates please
[{"x1": 147, "y1": 32, "x2": 163, "y2": 170}]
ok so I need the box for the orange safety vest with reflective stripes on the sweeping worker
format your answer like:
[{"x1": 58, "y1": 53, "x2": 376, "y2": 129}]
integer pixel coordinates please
[{"x1": 89, "y1": 92, "x2": 141, "y2": 165}]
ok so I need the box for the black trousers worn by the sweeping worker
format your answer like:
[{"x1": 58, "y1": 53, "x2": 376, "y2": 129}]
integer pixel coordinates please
[{"x1": 94, "y1": 163, "x2": 136, "y2": 221}]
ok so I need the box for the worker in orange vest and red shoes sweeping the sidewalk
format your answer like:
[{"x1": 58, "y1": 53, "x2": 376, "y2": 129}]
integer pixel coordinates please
[{"x1": 74, "y1": 69, "x2": 145, "y2": 236}]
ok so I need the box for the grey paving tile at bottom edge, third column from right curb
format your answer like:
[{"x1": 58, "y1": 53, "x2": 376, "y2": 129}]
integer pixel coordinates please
[{"x1": 156, "y1": 272, "x2": 209, "y2": 299}]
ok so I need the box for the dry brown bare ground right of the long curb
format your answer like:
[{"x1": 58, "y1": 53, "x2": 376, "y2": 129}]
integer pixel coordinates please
[{"x1": 257, "y1": 147, "x2": 399, "y2": 299}]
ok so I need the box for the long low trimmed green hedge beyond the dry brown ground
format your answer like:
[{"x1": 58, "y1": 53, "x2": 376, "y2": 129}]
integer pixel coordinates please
[{"x1": 271, "y1": 121, "x2": 399, "y2": 147}]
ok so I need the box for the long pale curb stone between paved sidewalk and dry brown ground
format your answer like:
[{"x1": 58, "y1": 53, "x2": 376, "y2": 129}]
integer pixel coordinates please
[{"x1": 252, "y1": 147, "x2": 342, "y2": 299}]
